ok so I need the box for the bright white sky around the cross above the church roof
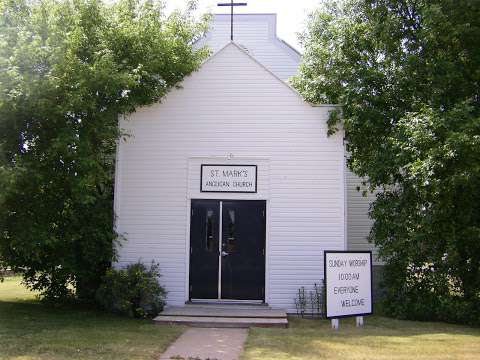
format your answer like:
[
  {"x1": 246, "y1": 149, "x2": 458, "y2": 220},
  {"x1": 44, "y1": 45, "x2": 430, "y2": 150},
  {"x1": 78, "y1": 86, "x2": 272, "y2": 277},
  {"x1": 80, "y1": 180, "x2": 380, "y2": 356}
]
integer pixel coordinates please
[{"x1": 165, "y1": 0, "x2": 321, "y2": 50}]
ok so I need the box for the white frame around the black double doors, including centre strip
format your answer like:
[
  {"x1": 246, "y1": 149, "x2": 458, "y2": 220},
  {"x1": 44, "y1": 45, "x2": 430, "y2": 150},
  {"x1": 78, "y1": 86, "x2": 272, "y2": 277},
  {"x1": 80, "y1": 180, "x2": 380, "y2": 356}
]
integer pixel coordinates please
[{"x1": 185, "y1": 197, "x2": 270, "y2": 304}]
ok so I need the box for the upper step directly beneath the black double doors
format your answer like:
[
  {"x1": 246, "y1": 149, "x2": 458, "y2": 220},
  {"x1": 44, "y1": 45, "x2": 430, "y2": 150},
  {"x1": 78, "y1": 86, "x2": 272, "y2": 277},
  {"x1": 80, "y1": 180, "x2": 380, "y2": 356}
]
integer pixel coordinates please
[{"x1": 159, "y1": 305, "x2": 287, "y2": 319}]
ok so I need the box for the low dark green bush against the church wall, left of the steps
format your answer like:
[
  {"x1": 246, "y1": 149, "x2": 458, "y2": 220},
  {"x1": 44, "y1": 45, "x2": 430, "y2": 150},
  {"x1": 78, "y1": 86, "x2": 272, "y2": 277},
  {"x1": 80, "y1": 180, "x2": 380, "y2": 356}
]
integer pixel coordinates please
[{"x1": 96, "y1": 262, "x2": 166, "y2": 318}]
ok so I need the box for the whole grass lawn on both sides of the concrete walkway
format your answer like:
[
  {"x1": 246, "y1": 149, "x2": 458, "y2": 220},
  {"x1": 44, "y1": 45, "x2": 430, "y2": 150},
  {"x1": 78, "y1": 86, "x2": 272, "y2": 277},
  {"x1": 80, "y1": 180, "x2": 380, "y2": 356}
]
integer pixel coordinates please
[{"x1": 4, "y1": 277, "x2": 480, "y2": 360}]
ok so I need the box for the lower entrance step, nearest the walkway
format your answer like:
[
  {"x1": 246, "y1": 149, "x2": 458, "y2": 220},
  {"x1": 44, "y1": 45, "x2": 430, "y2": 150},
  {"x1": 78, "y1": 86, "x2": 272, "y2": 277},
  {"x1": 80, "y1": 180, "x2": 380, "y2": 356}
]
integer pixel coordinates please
[{"x1": 153, "y1": 315, "x2": 288, "y2": 328}]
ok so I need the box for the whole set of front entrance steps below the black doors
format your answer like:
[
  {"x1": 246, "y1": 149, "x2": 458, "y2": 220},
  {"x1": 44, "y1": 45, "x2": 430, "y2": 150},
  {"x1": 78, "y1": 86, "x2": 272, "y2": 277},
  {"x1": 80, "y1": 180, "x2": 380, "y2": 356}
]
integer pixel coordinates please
[{"x1": 153, "y1": 304, "x2": 288, "y2": 328}]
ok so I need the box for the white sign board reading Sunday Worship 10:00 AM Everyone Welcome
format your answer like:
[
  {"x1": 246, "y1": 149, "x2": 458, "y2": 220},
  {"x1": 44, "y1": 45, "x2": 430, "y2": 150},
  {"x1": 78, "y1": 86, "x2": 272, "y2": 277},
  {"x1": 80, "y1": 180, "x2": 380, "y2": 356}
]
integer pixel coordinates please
[{"x1": 324, "y1": 251, "x2": 373, "y2": 319}]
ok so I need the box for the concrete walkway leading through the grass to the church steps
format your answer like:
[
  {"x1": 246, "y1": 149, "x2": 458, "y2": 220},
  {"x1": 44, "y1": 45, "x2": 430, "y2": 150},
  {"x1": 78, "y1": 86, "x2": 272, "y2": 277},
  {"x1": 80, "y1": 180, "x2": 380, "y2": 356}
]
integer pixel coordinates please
[{"x1": 160, "y1": 328, "x2": 248, "y2": 360}]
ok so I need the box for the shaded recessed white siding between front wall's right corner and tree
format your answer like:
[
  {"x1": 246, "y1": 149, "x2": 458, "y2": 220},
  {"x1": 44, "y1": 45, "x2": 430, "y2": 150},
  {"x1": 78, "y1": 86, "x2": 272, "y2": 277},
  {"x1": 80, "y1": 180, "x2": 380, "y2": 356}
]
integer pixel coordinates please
[{"x1": 346, "y1": 170, "x2": 381, "y2": 264}]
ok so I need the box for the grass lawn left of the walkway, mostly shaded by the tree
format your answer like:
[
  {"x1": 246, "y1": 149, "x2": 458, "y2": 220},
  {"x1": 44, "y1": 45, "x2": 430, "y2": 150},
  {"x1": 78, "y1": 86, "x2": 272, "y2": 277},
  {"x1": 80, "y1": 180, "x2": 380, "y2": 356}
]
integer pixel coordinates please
[{"x1": 0, "y1": 277, "x2": 184, "y2": 360}]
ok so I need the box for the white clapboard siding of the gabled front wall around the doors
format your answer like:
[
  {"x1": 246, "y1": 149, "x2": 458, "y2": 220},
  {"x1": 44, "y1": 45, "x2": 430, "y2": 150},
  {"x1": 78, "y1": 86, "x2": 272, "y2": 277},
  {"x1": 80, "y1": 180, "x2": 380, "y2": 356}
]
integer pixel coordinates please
[{"x1": 115, "y1": 43, "x2": 346, "y2": 311}]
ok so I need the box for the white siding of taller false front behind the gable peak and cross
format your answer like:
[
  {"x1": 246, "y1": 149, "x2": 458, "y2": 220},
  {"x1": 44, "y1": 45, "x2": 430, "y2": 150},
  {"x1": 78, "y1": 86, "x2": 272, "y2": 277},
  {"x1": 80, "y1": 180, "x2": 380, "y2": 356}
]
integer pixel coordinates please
[{"x1": 195, "y1": 14, "x2": 301, "y2": 81}]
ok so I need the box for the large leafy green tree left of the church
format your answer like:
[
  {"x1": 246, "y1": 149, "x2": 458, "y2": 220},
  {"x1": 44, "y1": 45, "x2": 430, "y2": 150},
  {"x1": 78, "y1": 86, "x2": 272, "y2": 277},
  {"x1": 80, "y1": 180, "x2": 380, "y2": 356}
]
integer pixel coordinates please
[{"x1": 0, "y1": 0, "x2": 207, "y2": 300}]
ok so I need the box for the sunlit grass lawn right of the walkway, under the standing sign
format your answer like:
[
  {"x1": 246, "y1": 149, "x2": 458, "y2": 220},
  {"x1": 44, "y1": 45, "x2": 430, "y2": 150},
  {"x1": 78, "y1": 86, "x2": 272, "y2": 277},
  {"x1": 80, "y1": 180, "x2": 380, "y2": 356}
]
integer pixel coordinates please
[{"x1": 242, "y1": 316, "x2": 480, "y2": 360}]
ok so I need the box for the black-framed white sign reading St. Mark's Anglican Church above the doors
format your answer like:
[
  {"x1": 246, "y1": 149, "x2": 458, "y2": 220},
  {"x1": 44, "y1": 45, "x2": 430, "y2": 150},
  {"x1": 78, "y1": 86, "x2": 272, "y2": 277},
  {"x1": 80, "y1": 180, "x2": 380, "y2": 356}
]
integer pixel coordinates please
[{"x1": 200, "y1": 164, "x2": 257, "y2": 193}]
